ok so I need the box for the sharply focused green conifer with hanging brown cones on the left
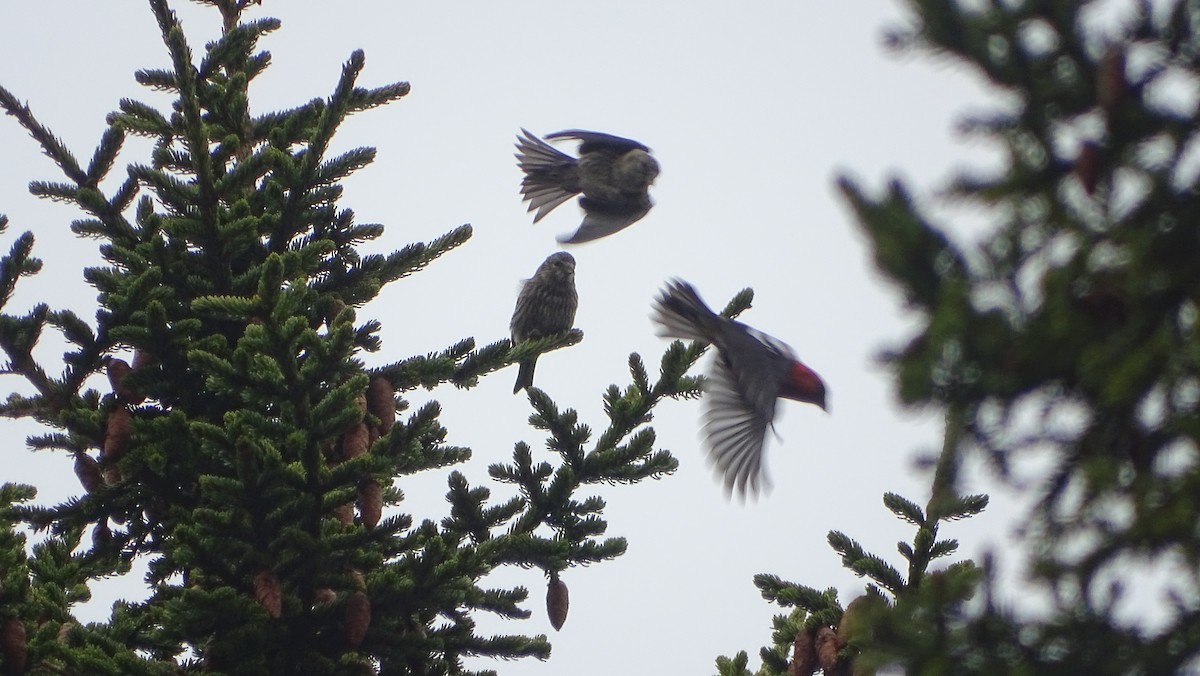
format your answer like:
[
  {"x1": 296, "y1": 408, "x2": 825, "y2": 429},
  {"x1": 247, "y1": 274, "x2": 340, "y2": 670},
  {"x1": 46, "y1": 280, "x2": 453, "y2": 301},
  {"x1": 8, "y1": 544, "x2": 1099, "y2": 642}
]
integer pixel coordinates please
[{"x1": 0, "y1": 0, "x2": 700, "y2": 675}]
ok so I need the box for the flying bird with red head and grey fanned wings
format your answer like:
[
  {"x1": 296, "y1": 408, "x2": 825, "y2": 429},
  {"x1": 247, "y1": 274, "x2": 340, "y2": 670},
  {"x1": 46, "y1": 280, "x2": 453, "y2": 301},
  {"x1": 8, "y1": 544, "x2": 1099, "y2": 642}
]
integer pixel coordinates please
[{"x1": 654, "y1": 280, "x2": 828, "y2": 495}]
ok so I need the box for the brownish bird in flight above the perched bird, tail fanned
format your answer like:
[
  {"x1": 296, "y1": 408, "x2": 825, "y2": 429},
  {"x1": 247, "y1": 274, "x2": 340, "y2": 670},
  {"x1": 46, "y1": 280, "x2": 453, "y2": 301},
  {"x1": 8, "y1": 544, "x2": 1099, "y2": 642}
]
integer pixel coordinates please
[{"x1": 516, "y1": 128, "x2": 659, "y2": 244}]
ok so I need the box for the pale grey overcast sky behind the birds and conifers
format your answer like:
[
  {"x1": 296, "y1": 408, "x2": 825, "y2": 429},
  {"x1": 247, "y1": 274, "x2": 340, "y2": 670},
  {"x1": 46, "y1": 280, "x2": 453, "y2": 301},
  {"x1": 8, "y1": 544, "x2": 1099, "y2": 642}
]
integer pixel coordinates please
[{"x1": 0, "y1": 0, "x2": 1051, "y2": 676}]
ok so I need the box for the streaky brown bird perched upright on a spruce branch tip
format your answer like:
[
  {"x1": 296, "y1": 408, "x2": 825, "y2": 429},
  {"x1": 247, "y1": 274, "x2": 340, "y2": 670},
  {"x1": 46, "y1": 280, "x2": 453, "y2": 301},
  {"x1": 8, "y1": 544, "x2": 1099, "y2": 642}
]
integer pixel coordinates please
[{"x1": 509, "y1": 251, "x2": 580, "y2": 394}]
